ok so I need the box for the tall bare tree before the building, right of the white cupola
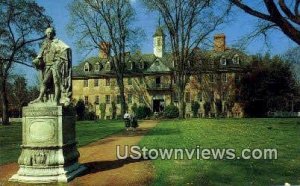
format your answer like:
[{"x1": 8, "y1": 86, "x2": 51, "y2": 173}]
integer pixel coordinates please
[{"x1": 144, "y1": 0, "x2": 230, "y2": 118}]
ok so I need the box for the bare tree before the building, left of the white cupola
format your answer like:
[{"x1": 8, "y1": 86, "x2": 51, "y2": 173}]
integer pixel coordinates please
[{"x1": 69, "y1": 0, "x2": 141, "y2": 114}]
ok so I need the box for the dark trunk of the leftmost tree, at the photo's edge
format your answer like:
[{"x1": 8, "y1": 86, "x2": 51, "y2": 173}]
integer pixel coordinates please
[{"x1": 0, "y1": 77, "x2": 9, "y2": 125}]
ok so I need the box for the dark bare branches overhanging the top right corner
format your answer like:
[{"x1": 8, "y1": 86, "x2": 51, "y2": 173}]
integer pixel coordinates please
[{"x1": 229, "y1": 0, "x2": 300, "y2": 45}]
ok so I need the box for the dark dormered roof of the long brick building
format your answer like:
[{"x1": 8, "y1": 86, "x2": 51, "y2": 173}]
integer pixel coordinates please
[{"x1": 73, "y1": 49, "x2": 251, "y2": 77}]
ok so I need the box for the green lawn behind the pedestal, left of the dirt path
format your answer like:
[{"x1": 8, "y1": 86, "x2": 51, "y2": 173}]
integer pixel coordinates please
[{"x1": 0, "y1": 120, "x2": 124, "y2": 165}]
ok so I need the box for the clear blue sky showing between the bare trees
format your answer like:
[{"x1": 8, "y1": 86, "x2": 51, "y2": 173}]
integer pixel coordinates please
[{"x1": 18, "y1": 0, "x2": 296, "y2": 84}]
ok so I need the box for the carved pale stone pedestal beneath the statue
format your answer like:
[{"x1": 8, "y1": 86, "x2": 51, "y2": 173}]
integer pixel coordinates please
[{"x1": 10, "y1": 103, "x2": 85, "y2": 183}]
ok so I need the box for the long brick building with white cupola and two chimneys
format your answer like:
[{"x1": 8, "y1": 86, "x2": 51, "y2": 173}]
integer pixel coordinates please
[{"x1": 72, "y1": 27, "x2": 251, "y2": 119}]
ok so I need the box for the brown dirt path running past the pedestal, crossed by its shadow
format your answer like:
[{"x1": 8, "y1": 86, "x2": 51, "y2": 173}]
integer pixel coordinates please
[{"x1": 0, "y1": 121, "x2": 157, "y2": 186}]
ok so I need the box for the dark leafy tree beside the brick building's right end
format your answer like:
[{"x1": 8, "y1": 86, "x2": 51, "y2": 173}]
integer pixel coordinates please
[{"x1": 240, "y1": 55, "x2": 299, "y2": 117}]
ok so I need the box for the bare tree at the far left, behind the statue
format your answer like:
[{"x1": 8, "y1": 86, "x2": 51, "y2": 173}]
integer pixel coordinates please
[{"x1": 0, "y1": 0, "x2": 51, "y2": 125}]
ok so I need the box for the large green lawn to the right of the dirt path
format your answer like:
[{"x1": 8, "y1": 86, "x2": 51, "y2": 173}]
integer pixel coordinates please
[{"x1": 139, "y1": 118, "x2": 300, "y2": 185}]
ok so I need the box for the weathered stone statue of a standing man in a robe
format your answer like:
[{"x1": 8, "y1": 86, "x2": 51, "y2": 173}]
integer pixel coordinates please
[{"x1": 31, "y1": 27, "x2": 72, "y2": 105}]
